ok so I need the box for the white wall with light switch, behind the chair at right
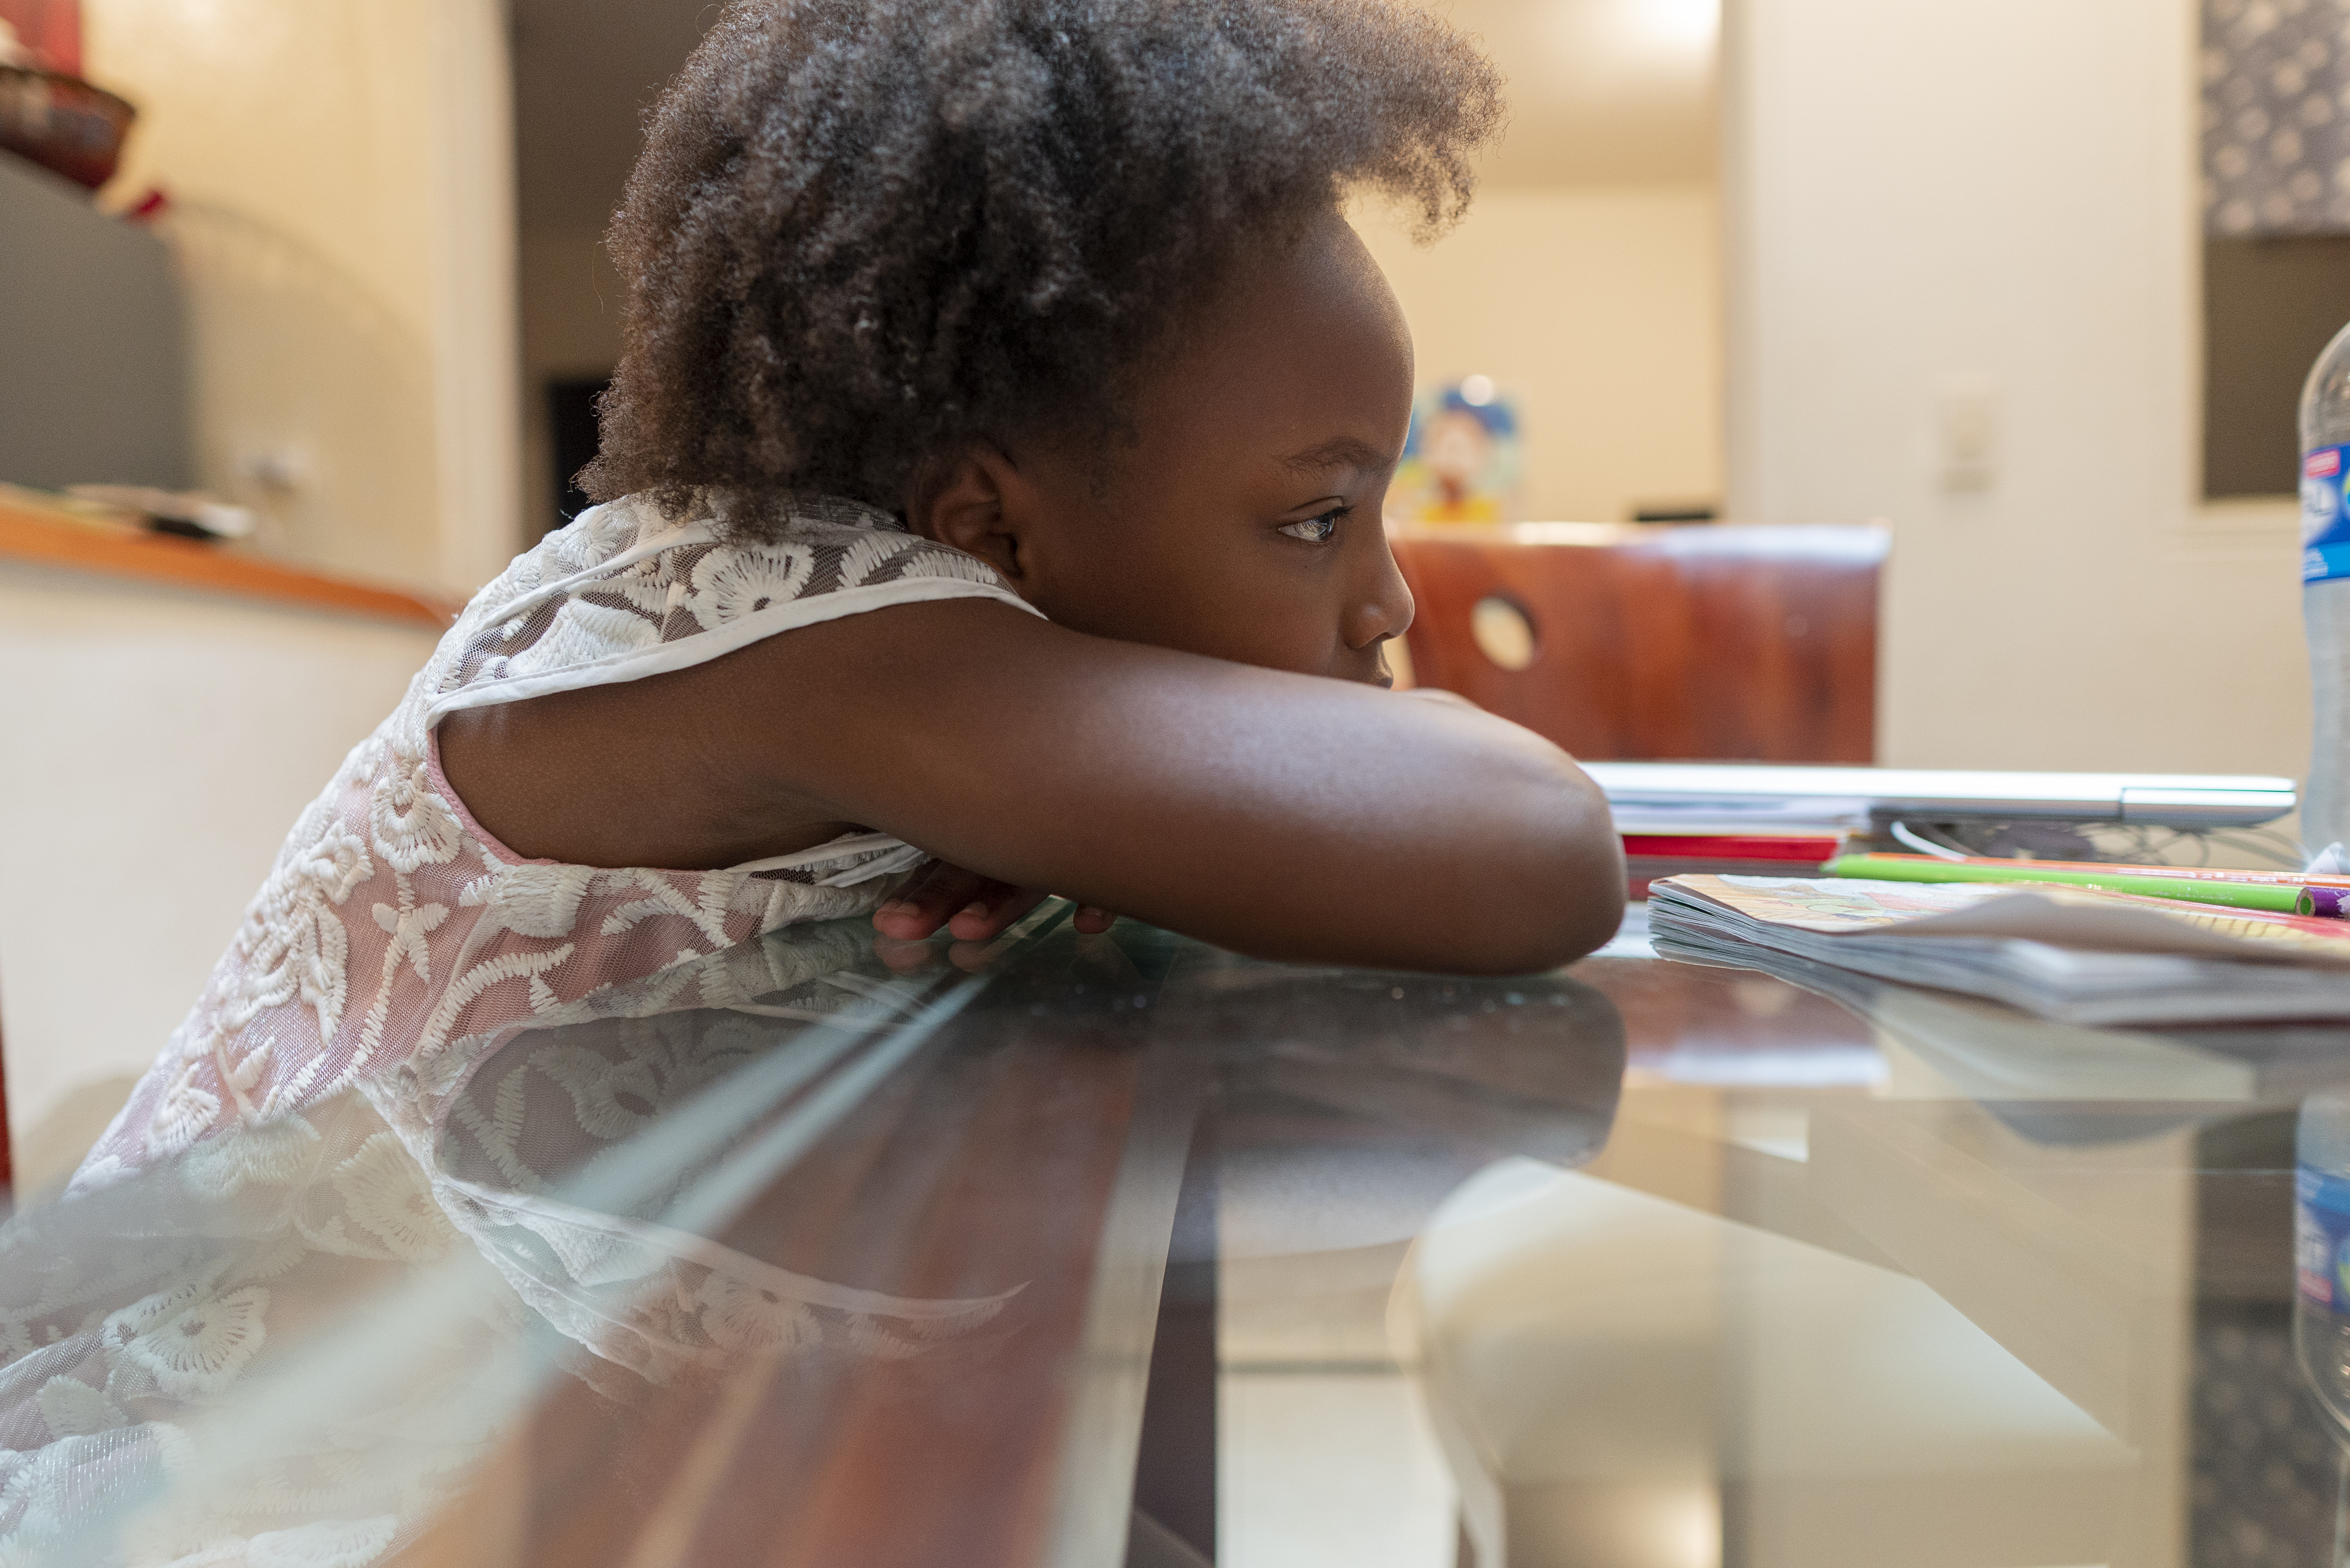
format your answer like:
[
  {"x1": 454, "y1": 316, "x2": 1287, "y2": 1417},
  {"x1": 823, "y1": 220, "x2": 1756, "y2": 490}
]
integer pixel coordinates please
[{"x1": 1725, "y1": 0, "x2": 2308, "y2": 774}]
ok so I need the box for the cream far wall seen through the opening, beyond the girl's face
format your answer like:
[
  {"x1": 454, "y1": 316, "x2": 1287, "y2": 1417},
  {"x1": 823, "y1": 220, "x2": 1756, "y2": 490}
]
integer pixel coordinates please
[{"x1": 1356, "y1": 183, "x2": 1722, "y2": 522}]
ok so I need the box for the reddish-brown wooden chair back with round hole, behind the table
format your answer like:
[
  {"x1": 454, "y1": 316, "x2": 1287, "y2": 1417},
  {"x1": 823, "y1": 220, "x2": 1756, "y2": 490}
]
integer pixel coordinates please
[{"x1": 1394, "y1": 522, "x2": 1889, "y2": 764}]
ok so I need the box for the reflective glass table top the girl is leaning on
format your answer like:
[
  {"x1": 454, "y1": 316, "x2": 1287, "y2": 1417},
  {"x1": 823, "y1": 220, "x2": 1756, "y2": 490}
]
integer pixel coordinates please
[{"x1": 0, "y1": 905, "x2": 2350, "y2": 1568}]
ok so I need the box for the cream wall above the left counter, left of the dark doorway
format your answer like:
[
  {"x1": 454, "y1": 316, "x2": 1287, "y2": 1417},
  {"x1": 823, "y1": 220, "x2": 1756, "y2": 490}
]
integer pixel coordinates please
[{"x1": 82, "y1": 0, "x2": 519, "y2": 590}]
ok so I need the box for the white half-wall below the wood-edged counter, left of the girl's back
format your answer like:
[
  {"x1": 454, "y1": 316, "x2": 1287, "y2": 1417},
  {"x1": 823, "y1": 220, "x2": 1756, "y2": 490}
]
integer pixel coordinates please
[{"x1": 0, "y1": 571, "x2": 435, "y2": 1171}]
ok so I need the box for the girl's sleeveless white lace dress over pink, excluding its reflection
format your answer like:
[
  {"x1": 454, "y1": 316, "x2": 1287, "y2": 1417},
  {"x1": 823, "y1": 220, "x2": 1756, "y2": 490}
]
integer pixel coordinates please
[{"x1": 75, "y1": 498, "x2": 1034, "y2": 1192}]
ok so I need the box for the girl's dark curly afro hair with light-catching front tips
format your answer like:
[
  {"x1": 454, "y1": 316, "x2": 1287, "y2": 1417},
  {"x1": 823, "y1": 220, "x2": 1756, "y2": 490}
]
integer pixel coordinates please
[{"x1": 580, "y1": 0, "x2": 1501, "y2": 533}]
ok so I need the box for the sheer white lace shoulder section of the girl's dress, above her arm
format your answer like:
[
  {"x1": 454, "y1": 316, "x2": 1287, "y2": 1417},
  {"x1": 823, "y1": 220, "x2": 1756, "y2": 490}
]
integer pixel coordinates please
[{"x1": 430, "y1": 496, "x2": 1034, "y2": 719}]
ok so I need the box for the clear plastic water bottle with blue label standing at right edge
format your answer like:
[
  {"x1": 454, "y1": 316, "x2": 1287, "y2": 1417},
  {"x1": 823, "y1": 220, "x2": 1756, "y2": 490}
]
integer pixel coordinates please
[{"x1": 2300, "y1": 327, "x2": 2350, "y2": 851}]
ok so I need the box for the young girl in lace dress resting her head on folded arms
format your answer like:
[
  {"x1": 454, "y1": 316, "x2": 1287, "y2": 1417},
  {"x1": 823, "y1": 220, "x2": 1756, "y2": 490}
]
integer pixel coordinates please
[{"x1": 78, "y1": 0, "x2": 1624, "y2": 1187}]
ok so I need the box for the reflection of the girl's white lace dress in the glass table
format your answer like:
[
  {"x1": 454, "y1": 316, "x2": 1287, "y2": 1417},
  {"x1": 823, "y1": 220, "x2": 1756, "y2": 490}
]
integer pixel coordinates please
[{"x1": 0, "y1": 926, "x2": 1004, "y2": 1568}]
